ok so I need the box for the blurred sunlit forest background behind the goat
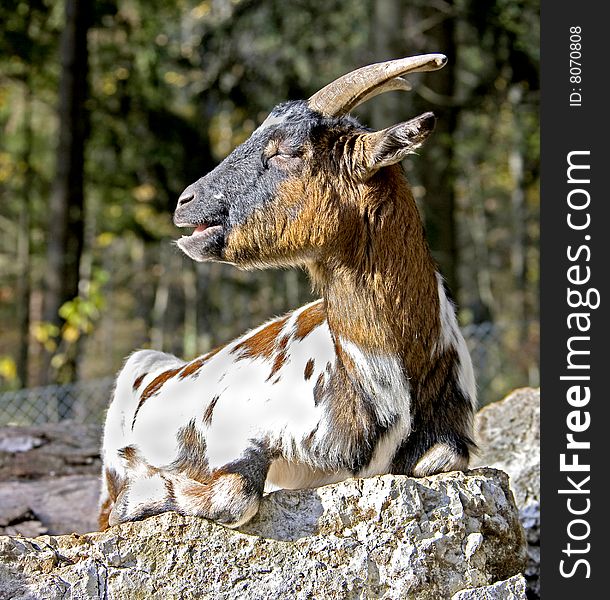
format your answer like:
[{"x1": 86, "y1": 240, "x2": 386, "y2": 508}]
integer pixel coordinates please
[{"x1": 0, "y1": 0, "x2": 540, "y2": 424}]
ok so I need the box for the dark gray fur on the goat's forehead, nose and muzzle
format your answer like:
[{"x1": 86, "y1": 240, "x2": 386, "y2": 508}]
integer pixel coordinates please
[{"x1": 169, "y1": 101, "x2": 362, "y2": 261}]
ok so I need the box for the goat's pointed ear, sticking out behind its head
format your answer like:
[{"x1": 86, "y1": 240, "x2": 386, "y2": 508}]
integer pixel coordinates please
[{"x1": 361, "y1": 112, "x2": 436, "y2": 179}]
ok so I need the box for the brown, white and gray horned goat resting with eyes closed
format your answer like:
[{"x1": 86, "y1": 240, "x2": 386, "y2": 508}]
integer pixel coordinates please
[{"x1": 100, "y1": 54, "x2": 476, "y2": 528}]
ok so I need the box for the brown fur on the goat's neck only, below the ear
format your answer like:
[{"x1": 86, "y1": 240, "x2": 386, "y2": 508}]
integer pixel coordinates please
[{"x1": 310, "y1": 166, "x2": 440, "y2": 390}]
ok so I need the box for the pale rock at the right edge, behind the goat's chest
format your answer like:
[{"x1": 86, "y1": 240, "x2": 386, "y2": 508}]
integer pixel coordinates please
[{"x1": 472, "y1": 388, "x2": 540, "y2": 598}]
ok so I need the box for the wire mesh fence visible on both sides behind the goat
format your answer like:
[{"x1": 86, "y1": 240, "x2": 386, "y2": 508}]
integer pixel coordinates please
[{"x1": 0, "y1": 323, "x2": 539, "y2": 426}]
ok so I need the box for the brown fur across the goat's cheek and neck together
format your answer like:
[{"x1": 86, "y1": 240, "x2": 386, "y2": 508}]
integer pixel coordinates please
[{"x1": 229, "y1": 143, "x2": 440, "y2": 384}]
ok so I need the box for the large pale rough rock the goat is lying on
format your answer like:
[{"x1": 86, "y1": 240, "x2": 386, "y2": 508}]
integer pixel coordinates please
[{"x1": 0, "y1": 469, "x2": 526, "y2": 600}]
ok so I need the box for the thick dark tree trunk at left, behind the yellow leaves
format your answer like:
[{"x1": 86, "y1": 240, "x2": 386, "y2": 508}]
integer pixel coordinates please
[{"x1": 42, "y1": 0, "x2": 91, "y2": 390}]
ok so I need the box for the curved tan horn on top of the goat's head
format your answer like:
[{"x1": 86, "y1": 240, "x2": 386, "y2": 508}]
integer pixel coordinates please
[{"x1": 307, "y1": 54, "x2": 447, "y2": 117}]
